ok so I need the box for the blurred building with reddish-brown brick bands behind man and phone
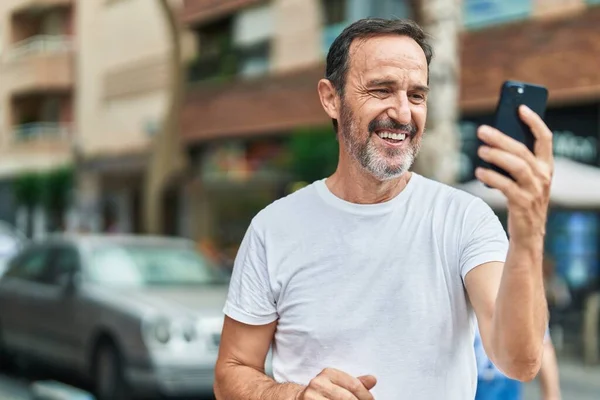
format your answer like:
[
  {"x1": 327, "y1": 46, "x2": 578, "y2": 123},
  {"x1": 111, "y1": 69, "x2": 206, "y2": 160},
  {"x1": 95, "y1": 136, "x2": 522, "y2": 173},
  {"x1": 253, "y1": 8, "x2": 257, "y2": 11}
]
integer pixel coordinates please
[{"x1": 182, "y1": 0, "x2": 600, "y2": 288}]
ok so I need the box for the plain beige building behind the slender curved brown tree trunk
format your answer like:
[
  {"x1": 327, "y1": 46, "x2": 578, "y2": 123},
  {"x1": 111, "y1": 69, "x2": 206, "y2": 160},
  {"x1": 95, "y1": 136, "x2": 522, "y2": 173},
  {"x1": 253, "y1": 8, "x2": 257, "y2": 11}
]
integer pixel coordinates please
[{"x1": 75, "y1": 0, "x2": 179, "y2": 232}]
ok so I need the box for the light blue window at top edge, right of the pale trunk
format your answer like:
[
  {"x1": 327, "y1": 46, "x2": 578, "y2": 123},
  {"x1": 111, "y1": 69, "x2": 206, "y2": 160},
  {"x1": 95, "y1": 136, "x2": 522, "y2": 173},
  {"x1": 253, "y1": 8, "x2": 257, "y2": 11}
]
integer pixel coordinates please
[{"x1": 463, "y1": 0, "x2": 533, "y2": 29}]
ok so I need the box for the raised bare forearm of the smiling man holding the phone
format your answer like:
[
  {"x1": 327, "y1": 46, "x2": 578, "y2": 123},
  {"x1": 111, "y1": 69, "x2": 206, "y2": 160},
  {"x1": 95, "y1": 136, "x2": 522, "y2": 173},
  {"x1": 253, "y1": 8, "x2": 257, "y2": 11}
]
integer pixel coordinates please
[{"x1": 492, "y1": 238, "x2": 548, "y2": 380}]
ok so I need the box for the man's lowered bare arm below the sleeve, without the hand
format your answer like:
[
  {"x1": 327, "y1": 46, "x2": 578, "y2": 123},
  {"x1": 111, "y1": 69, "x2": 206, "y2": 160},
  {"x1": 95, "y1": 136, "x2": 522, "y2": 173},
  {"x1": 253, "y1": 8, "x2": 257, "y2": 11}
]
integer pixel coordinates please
[{"x1": 214, "y1": 317, "x2": 303, "y2": 400}]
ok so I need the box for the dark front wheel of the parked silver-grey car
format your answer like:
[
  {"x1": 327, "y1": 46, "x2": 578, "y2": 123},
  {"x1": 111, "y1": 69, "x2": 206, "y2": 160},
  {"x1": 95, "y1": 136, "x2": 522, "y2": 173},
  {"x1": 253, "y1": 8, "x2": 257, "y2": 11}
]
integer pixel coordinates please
[{"x1": 94, "y1": 343, "x2": 129, "y2": 400}]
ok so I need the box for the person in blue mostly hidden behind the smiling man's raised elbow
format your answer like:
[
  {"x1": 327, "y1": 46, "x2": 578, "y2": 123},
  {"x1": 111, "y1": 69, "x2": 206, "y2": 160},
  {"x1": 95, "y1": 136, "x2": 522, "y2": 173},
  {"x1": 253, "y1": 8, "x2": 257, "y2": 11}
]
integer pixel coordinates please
[{"x1": 475, "y1": 331, "x2": 561, "y2": 400}]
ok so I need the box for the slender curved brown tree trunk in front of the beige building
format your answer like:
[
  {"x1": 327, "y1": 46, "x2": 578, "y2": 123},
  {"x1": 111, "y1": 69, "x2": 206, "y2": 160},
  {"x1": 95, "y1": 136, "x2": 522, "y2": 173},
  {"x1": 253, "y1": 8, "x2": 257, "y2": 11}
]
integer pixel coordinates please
[{"x1": 143, "y1": 0, "x2": 187, "y2": 234}]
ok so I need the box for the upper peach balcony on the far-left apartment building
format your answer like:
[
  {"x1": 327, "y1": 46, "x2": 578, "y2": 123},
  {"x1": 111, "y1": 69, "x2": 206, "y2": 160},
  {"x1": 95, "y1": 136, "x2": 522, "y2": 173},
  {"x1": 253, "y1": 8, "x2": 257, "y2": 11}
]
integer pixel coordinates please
[{"x1": 2, "y1": 35, "x2": 75, "y2": 95}]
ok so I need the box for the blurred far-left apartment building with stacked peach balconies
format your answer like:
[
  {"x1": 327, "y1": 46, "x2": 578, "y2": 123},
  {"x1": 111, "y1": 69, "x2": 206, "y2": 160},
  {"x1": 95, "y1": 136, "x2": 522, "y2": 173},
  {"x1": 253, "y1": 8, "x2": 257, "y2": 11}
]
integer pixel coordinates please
[{"x1": 0, "y1": 0, "x2": 77, "y2": 232}]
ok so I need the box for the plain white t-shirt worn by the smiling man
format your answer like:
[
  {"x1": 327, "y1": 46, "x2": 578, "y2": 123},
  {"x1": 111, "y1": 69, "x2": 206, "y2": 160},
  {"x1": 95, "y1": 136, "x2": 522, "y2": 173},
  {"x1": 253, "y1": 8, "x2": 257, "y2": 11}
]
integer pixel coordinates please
[{"x1": 224, "y1": 173, "x2": 508, "y2": 400}]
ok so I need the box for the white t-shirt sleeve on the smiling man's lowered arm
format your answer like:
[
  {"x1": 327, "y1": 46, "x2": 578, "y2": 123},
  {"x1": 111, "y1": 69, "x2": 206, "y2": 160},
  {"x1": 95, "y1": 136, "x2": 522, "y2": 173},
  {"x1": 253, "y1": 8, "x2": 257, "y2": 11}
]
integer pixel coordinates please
[{"x1": 223, "y1": 225, "x2": 277, "y2": 325}]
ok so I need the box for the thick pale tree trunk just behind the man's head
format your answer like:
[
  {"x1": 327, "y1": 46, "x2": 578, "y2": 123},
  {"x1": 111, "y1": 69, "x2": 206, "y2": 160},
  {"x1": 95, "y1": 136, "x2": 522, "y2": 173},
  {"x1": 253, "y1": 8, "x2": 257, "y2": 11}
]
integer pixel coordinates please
[{"x1": 411, "y1": 0, "x2": 461, "y2": 184}]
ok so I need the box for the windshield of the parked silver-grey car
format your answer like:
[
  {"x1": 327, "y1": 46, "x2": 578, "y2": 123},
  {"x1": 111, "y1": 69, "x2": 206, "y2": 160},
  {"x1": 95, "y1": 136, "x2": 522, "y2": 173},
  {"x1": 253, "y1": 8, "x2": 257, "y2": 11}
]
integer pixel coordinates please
[{"x1": 90, "y1": 244, "x2": 223, "y2": 286}]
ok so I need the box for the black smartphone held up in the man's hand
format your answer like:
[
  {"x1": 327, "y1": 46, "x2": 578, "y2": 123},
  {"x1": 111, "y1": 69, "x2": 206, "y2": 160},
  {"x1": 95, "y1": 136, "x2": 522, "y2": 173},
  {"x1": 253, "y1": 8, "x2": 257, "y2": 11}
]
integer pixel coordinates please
[{"x1": 479, "y1": 81, "x2": 548, "y2": 179}]
